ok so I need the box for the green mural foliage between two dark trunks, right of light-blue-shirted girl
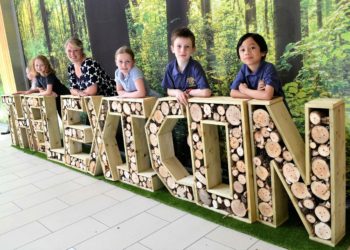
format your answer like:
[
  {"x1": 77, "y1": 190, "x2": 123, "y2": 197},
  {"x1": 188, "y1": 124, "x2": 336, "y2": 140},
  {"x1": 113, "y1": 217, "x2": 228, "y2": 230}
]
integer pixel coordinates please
[{"x1": 127, "y1": 0, "x2": 168, "y2": 92}]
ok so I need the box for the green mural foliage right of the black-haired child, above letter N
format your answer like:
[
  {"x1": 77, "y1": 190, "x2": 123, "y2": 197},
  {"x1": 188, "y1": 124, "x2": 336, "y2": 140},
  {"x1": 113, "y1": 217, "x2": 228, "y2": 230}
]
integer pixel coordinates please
[{"x1": 279, "y1": 1, "x2": 350, "y2": 193}]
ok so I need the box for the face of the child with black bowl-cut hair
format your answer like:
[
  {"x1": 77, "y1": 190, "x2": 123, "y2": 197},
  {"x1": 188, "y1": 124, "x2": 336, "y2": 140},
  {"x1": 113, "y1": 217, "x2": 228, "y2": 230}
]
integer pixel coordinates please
[{"x1": 238, "y1": 37, "x2": 266, "y2": 71}]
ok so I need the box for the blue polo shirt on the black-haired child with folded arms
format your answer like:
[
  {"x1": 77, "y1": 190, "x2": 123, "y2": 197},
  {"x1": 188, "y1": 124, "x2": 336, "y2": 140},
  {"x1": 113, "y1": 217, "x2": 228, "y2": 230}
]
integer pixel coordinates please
[{"x1": 230, "y1": 61, "x2": 284, "y2": 97}]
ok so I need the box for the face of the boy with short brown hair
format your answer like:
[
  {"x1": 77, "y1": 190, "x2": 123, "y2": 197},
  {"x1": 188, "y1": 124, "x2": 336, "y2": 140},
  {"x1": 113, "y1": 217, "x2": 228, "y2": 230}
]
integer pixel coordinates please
[{"x1": 171, "y1": 37, "x2": 195, "y2": 64}]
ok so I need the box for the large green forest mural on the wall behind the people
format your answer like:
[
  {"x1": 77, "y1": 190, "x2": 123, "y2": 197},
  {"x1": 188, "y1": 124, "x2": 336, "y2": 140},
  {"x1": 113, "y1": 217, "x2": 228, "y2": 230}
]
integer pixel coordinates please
[{"x1": 10, "y1": 0, "x2": 350, "y2": 193}]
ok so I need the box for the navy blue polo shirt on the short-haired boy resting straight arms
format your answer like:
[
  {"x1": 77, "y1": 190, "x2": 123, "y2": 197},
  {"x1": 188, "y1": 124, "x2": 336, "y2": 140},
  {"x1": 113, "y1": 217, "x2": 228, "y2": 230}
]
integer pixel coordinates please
[{"x1": 162, "y1": 57, "x2": 209, "y2": 91}]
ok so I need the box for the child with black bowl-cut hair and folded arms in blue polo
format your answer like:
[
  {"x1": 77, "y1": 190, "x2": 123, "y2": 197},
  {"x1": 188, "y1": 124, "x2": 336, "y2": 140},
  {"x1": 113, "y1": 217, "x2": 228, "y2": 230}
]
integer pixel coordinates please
[{"x1": 230, "y1": 33, "x2": 284, "y2": 100}]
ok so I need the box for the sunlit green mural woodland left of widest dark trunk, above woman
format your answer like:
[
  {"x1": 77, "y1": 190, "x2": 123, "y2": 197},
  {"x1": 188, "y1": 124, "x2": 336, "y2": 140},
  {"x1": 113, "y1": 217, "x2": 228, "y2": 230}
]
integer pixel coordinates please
[{"x1": 15, "y1": 0, "x2": 90, "y2": 84}]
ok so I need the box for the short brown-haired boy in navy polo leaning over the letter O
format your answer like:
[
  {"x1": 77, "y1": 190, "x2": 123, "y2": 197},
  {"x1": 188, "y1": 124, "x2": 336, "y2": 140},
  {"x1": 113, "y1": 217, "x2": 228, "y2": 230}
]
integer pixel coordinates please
[{"x1": 162, "y1": 28, "x2": 211, "y2": 105}]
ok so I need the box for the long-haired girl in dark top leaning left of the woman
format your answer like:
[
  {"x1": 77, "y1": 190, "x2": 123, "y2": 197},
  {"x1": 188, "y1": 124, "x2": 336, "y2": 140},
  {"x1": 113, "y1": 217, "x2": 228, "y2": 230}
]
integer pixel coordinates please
[{"x1": 28, "y1": 55, "x2": 70, "y2": 117}]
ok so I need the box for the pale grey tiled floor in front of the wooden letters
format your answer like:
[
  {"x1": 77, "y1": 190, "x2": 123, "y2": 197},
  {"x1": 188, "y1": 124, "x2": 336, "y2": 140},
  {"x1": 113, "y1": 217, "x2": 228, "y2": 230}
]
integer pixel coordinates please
[{"x1": 0, "y1": 132, "x2": 281, "y2": 250}]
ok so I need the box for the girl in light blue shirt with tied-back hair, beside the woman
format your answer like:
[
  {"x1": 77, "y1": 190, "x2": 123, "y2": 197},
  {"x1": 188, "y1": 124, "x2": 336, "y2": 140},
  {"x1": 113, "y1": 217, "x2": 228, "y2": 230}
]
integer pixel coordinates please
[{"x1": 115, "y1": 46, "x2": 158, "y2": 98}]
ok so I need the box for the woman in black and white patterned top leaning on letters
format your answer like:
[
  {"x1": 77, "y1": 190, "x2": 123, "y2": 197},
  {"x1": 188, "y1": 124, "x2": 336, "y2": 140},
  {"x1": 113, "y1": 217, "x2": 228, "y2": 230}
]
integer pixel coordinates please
[{"x1": 65, "y1": 37, "x2": 115, "y2": 96}]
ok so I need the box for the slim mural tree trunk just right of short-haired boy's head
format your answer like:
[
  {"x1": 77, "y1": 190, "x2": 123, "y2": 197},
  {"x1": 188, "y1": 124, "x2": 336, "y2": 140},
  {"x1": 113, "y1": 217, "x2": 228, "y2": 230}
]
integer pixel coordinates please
[{"x1": 201, "y1": 0, "x2": 215, "y2": 78}]
